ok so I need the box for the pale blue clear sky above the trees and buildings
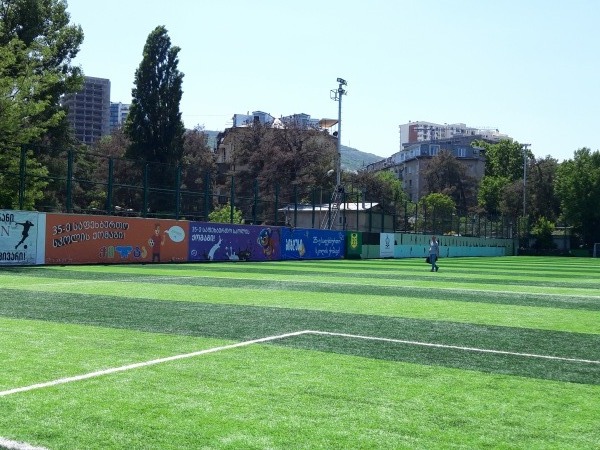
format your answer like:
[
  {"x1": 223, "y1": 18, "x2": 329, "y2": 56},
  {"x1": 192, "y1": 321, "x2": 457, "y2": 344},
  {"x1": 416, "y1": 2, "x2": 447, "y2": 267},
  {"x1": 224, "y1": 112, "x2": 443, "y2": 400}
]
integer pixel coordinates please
[{"x1": 68, "y1": 0, "x2": 600, "y2": 161}]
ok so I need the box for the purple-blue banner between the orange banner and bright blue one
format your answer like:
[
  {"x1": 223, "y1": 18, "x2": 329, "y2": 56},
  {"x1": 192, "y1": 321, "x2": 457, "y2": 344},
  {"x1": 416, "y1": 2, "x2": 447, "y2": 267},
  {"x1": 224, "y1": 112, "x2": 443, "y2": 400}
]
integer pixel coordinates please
[{"x1": 188, "y1": 222, "x2": 281, "y2": 261}]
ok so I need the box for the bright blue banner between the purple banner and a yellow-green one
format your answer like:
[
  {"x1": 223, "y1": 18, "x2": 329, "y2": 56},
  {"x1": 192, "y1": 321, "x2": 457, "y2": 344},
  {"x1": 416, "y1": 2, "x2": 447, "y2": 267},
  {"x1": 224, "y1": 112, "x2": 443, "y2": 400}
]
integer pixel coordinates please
[{"x1": 281, "y1": 228, "x2": 346, "y2": 259}]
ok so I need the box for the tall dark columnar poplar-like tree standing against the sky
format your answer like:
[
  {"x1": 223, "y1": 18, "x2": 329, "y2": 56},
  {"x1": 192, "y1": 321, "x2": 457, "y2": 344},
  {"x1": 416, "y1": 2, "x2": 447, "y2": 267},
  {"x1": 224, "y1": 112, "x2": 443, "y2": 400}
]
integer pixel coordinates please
[{"x1": 125, "y1": 26, "x2": 185, "y2": 197}]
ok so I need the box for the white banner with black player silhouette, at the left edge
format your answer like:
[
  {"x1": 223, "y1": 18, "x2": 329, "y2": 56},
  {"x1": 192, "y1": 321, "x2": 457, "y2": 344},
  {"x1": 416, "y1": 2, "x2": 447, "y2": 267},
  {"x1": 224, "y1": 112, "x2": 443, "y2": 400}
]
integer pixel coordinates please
[{"x1": 0, "y1": 210, "x2": 44, "y2": 266}]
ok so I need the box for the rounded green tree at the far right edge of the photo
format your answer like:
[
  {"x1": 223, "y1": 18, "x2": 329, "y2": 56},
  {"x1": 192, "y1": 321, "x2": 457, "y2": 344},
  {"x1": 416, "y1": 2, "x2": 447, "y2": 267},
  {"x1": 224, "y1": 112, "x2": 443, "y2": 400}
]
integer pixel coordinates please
[{"x1": 555, "y1": 148, "x2": 600, "y2": 247}]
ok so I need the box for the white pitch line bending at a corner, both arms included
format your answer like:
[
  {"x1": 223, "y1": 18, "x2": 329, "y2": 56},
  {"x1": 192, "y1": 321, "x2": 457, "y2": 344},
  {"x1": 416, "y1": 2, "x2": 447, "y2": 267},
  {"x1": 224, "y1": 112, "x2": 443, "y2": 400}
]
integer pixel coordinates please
[{"x1": 0, "y1": 330, "x2": 600, "y2": 397}]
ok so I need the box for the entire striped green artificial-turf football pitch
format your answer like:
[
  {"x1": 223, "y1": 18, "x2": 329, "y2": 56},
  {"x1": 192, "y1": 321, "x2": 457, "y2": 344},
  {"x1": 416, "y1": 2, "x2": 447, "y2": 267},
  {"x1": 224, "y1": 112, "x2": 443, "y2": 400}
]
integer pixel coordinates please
[{"x1": 0, "y1": 257, "x2": 600, "y2": 450}]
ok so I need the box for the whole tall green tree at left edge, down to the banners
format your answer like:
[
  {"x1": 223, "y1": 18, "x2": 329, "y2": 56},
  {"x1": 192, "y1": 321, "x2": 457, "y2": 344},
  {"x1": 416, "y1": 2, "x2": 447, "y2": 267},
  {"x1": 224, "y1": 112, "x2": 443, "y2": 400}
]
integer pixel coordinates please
[{"x1": 0, "y1": 0, "x2": 83, "y2": 208}]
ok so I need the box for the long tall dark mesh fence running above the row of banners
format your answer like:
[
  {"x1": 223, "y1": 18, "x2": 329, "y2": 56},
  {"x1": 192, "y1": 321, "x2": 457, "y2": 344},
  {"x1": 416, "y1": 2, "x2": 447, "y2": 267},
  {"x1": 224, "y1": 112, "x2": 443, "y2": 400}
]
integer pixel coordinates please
[{"x1": 0, "y1": 150, "x2": 522, "y2": 239}]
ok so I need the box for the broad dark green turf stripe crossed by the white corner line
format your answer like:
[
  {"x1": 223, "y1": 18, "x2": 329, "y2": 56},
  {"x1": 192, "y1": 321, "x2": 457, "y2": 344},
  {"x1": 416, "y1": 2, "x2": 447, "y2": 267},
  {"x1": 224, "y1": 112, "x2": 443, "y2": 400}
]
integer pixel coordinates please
[{"x1": 0, "y1": 291, "x2": 600, "y2": 384}]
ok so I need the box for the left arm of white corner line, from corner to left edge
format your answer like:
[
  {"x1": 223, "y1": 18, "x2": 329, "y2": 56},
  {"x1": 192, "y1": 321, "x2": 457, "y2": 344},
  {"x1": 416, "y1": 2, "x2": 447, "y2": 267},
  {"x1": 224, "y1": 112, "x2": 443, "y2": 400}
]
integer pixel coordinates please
[{"x1": 0, "y1": 331, "x2": 306, "y2": 397}]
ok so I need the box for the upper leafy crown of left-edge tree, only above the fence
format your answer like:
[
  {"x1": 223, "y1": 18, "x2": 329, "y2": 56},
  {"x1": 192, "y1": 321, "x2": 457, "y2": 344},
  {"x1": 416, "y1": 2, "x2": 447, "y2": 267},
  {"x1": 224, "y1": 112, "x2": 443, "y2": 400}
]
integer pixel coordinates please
[{"x1": 0, "y1": 0, "x2": 83, "y2": 149}]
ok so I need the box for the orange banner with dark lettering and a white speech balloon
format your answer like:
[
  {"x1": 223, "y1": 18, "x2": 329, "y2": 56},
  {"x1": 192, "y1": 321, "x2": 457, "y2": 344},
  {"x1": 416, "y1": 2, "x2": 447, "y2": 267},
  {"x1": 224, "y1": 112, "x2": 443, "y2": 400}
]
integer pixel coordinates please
[{"x1": 45, "y1": 214, "x2": 189, "y2": 264}]
